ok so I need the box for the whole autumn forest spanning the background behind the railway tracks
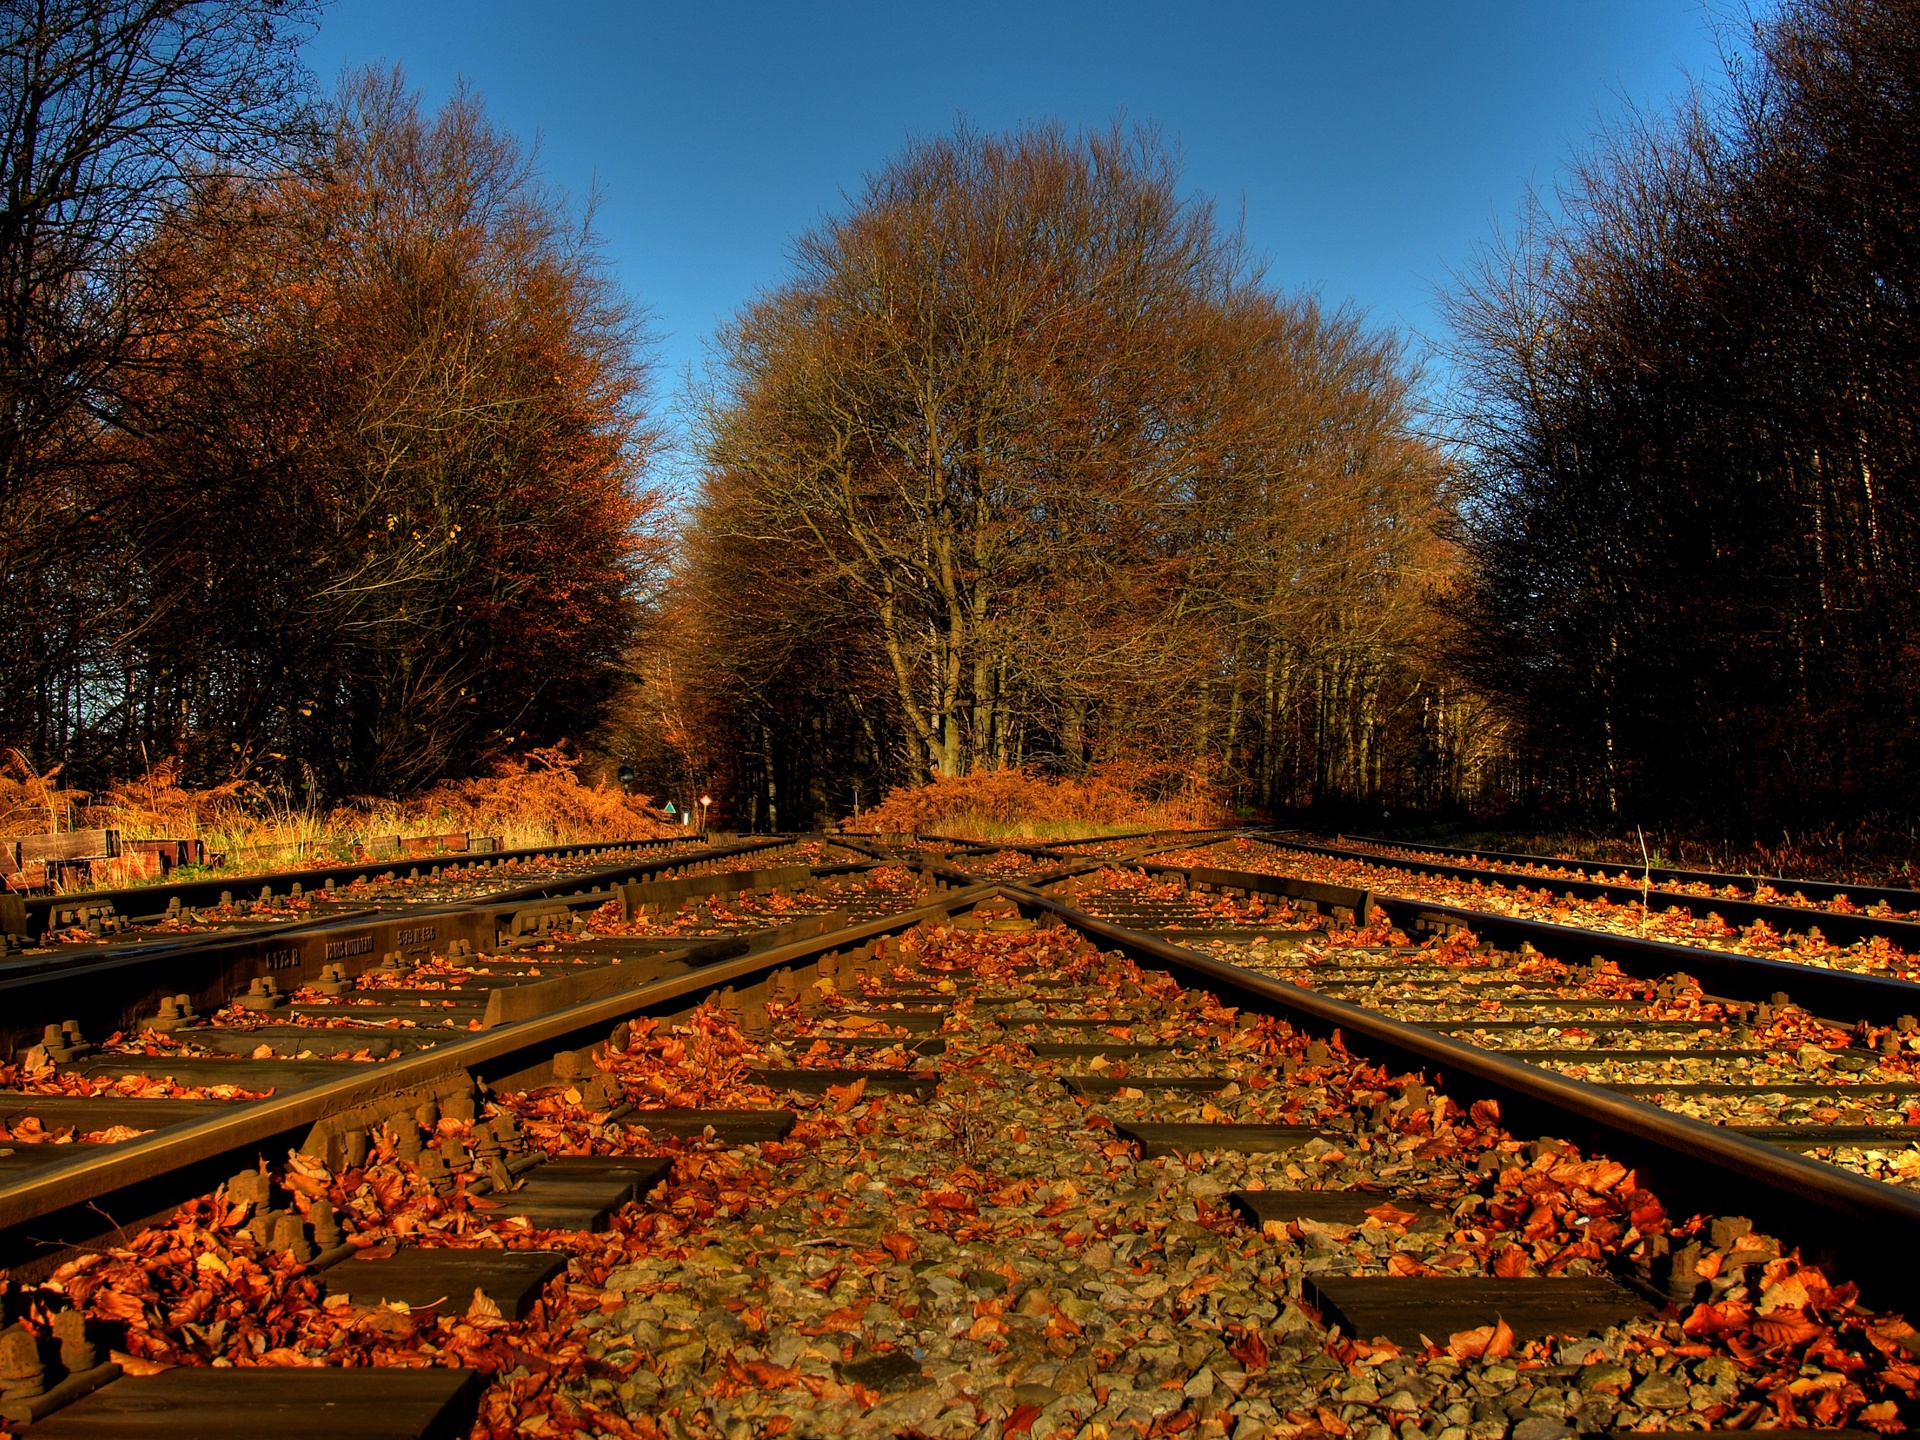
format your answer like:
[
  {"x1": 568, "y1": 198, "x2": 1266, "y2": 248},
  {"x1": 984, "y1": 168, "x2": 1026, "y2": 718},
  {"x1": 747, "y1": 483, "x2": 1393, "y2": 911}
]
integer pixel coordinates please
[{"x1": 0, "y1": 0, "x2": 1920, "y2": 835}]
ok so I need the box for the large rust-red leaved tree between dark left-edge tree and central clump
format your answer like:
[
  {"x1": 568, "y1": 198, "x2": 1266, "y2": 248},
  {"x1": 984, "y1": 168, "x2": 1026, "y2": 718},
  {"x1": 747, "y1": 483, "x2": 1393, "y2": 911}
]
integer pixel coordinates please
[{"x1": 100, "y1": 71, "x2": 659, "y2": 795}]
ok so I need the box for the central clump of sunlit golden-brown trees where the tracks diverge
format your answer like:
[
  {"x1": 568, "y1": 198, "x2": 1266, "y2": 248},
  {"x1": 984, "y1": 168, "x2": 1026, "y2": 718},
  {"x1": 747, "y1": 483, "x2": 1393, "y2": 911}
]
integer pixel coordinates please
[{"x1": 632, "y1": 127, "x2": 1476, "y2": 828}]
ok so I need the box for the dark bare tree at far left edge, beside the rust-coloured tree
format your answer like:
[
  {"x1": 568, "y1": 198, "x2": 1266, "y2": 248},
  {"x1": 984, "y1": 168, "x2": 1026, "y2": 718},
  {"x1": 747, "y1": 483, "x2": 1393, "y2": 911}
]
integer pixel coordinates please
[{"x1": 0, "y1": 0, "x2": 315, "y2": 755}]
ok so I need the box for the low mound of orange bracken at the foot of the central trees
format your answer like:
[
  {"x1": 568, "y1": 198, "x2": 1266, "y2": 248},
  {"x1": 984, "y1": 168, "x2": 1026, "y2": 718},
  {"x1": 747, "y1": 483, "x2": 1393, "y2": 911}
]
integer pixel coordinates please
[{"x1": 851, "y1": 766, "x2": 1219, "y2": 841}]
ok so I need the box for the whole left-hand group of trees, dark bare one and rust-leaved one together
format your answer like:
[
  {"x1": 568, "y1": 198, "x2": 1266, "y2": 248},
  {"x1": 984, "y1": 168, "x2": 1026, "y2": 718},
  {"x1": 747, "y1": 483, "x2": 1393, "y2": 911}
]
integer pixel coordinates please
[{"x1": 0, "y1": 0, "x2": 662, "y2": 801}]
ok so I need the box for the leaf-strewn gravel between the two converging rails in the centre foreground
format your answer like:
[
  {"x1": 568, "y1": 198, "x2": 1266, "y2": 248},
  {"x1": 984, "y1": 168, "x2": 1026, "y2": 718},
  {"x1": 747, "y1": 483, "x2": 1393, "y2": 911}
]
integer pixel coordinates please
[{"x1": 3, "y1": 912, "x2": 1920, "y2": 1440}]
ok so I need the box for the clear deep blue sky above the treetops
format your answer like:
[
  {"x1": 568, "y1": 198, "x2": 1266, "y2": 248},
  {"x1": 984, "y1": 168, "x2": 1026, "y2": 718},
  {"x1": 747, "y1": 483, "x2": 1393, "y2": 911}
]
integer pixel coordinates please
[{"x1": 307, "y1": 0, "x2": 1758, "y2": 433}]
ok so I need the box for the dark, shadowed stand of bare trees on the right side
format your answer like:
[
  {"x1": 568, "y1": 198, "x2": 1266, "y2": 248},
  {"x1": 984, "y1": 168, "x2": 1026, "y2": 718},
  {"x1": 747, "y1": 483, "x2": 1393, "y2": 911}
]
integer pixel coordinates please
[{"x1": 1452, "y1": 0, "x2": 1920, "y2": 837}]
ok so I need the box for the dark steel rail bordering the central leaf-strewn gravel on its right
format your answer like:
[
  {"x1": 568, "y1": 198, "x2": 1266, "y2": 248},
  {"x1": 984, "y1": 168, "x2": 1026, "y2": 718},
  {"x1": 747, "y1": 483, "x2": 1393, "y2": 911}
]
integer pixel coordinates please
[{"x1": 1002, "y1": 885, "x2": 1920, "y2": 1304}]
